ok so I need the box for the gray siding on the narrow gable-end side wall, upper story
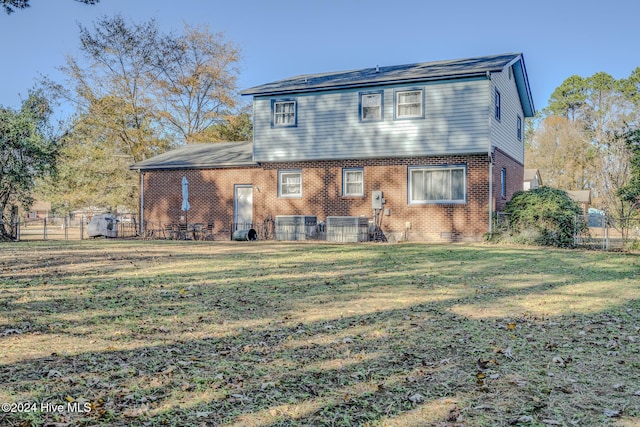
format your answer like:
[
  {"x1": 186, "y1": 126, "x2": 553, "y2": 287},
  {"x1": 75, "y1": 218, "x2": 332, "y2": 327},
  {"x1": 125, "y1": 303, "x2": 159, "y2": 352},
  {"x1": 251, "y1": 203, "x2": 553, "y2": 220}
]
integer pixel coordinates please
[{"x1": 491, "y1": 69, "x2": 524, "y2": 165}]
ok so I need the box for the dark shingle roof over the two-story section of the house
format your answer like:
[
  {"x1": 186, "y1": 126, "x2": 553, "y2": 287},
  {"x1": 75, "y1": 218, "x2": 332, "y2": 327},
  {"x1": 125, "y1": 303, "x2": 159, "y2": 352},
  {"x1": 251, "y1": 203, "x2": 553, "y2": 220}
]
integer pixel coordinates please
[{"x1": 240, "y1": 53, "x2": 521, "y2": 95}]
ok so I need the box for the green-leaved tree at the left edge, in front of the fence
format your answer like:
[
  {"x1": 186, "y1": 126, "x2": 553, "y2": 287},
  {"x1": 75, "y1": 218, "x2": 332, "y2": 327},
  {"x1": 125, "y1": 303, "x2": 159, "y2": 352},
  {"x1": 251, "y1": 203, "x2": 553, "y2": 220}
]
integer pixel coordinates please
[{"x1": 0, "y1": 92, "x2": 58, "y2": 240}]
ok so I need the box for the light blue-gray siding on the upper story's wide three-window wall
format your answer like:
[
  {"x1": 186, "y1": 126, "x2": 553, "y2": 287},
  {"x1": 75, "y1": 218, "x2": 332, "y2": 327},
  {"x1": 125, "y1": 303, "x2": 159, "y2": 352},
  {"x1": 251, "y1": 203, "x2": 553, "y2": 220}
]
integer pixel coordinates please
[{"x1": 254, "y1": 79, "x2": 491, "y2": 162}]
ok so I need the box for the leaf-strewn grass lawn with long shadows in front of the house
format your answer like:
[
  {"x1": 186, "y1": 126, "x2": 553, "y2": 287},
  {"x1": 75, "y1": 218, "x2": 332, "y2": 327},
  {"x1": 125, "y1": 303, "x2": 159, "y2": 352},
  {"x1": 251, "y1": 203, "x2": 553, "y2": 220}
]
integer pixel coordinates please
[{"x1": 0, "y1": 240, "x2": 640, "y2": 427}]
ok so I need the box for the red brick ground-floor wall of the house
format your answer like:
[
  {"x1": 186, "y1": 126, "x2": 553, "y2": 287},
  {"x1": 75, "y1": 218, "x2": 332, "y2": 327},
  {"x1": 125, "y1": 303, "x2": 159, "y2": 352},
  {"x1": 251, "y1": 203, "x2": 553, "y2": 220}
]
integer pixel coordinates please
[{"x1": 139, "y1": 151, "x2": 523, "y2": 241}]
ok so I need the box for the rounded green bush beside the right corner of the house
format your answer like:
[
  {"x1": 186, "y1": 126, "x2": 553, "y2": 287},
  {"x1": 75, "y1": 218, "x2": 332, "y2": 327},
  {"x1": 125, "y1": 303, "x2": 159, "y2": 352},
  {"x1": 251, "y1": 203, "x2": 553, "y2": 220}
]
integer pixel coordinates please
[{"x1": 504, "y1": 187, "x2": 583, "y2": 248}]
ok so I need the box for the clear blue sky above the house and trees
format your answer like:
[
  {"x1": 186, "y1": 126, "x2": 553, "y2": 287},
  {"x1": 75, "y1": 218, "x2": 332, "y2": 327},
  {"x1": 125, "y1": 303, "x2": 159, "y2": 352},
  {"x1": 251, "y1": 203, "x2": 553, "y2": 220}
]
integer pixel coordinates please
[{"x1": 0, "y1": 0, "x2": 640, "y2": 115}]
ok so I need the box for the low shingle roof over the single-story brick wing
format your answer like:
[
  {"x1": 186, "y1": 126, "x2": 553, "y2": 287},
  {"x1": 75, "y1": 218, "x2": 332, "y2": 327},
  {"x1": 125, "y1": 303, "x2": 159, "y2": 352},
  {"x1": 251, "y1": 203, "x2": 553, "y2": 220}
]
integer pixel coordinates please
[{"x1": 129, "y1": 142, "x2": 257, "y2": 171}]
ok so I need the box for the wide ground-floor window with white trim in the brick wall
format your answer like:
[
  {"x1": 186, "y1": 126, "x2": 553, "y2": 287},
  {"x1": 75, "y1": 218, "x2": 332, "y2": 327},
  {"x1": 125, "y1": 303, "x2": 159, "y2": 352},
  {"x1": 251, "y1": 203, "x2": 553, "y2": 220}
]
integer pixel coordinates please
[{"x1": 409, "y1": 165, "x2": 467, "y2": 203}]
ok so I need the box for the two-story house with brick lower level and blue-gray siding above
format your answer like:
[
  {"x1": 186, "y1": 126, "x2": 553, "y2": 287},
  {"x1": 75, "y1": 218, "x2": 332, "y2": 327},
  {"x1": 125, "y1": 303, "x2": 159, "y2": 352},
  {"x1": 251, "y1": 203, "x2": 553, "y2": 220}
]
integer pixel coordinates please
[{"x1": 132, "y1": 53, "x2": 535, "y2": 241}]
